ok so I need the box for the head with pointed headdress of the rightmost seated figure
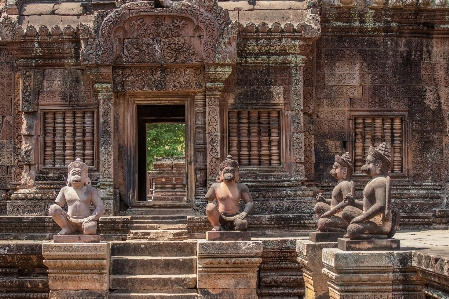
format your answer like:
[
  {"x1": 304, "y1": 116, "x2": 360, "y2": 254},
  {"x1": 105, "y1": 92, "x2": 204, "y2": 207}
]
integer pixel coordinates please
[{"x1": 361, "y1": 142, "x2": 391, "y2": 177}]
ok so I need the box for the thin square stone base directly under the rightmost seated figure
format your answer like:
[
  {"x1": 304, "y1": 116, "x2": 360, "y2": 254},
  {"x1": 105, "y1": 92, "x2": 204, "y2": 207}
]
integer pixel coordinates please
[{"x1": 338, "y1": 238, "x2": 401, "y2": 251}]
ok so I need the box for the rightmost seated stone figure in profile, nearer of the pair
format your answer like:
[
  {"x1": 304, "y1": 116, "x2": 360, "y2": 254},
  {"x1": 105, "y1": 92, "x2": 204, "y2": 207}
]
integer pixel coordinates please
[{"x1": 342, "y1": 142, "x2": 399, "y2": 240}]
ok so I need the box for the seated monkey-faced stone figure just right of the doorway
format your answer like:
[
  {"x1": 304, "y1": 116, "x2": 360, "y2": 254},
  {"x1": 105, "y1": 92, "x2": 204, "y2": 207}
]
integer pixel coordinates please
[{"x1": 205, "y1": 156, "x2": 254, "y2": 231}]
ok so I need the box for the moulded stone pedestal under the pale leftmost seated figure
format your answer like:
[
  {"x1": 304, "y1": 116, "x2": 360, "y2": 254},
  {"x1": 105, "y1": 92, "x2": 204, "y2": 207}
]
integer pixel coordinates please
[{"x1": 42, "y1": 243, "x2": 110, "y2": 299}]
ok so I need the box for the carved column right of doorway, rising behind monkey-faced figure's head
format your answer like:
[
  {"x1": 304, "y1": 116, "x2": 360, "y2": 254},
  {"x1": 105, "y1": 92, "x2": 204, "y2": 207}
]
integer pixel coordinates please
[{"x1": 206, "y1": 65, "x2": 232, "y2": 181}]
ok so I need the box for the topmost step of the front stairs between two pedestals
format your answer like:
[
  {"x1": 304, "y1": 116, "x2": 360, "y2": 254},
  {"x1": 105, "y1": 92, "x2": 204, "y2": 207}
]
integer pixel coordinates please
[{"x1": 111, "y1": 240, "x2": 197, "y2": 257}]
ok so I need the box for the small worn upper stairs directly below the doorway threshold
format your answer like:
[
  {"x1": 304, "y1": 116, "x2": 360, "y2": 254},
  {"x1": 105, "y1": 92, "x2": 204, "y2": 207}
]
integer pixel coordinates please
[{"x1": 127, "y1": 215, "x2": 189, "y2": 241}]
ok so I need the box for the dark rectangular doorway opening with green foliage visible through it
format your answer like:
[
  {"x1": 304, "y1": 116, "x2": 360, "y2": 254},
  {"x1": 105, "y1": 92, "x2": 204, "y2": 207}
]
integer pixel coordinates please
[{"x1": 137, "y1": 105, "x2": 187, "y2": 202}]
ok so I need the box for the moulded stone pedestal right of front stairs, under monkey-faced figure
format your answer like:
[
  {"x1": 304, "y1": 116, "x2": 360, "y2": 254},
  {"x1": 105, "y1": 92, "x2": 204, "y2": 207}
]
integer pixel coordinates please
[{"x1": 197, "y1": 241, "x2": 262, "y2": 299}]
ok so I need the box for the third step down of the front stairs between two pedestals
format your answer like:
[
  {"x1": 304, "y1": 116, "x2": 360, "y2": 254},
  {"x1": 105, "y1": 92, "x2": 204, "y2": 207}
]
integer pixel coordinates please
[{"x1": 109, "y1": 274, "x2": 196, "y2": 292}]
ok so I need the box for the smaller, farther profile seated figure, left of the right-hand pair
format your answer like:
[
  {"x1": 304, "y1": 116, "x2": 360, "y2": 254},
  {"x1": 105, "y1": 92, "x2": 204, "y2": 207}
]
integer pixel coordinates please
[{"x1": 314, "y1": 152, "x2": 354, "y2": 232}]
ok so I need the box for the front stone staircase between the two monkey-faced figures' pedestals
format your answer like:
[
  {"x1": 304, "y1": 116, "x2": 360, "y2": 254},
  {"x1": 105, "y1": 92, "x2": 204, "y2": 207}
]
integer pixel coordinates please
[{"x1": 109, "y1": 241, "x2": 198, "y2": 299}]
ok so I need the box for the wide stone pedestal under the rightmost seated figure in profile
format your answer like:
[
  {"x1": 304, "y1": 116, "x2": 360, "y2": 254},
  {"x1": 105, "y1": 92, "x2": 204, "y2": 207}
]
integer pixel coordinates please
[{"x1": 323, "y1": 248, "x2": 425, "y2": 299}]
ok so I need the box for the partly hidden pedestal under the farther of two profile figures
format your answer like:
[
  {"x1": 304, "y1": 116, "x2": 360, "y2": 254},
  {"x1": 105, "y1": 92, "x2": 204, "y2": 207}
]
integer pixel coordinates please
[{"x1": 296, "y1": 240, "x2": 338, "y2": 299}]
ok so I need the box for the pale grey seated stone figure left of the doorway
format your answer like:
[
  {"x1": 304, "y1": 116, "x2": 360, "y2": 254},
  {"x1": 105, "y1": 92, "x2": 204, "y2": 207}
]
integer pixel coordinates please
[{"x1": 49, "y1": 158, "x2": 105, "y2": 235}]
